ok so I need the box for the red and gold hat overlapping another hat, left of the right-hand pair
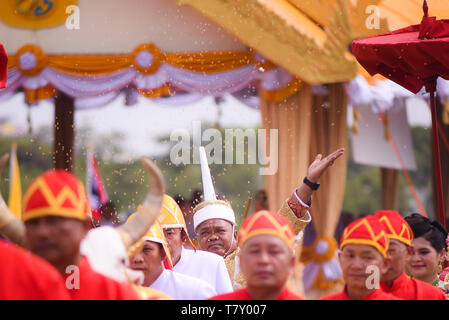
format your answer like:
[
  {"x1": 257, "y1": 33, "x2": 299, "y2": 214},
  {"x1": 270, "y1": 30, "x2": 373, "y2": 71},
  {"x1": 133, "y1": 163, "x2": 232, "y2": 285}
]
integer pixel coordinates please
[{"x1": 340, "y1": 215, "x2": 389, "y2": 257}]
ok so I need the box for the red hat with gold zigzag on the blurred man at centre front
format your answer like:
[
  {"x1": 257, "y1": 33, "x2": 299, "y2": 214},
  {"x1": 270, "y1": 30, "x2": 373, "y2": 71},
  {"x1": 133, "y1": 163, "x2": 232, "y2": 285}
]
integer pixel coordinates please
[{"x1": 239, "y1": 210, "x2": 295, "y2": 249}]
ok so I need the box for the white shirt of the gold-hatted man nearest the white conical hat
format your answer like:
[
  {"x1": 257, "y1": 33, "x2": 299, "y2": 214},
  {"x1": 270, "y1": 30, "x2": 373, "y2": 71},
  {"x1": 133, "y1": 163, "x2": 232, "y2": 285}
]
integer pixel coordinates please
[{"x1": 173, "y1": 248, "x2": 233, "y2": 294}]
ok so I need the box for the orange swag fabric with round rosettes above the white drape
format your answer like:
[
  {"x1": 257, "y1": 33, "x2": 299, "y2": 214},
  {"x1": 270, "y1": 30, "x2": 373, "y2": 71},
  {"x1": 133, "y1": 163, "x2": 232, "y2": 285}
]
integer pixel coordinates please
[{"x1": 8, "y1": 43, "x2": 302, "y2": 104}]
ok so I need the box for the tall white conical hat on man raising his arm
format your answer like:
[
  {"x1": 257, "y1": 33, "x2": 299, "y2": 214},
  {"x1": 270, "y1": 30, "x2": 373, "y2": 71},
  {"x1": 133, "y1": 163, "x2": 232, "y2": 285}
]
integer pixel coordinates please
[{"x1": 193, "y1": 147, "x2": 235, "y2": 230}]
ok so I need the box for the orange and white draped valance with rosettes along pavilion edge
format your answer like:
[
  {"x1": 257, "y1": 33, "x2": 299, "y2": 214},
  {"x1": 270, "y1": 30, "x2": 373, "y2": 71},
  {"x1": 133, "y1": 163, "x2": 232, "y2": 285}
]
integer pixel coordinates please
[{"x1": 8, "y1": 43, "x2": 302, "y2": 104}]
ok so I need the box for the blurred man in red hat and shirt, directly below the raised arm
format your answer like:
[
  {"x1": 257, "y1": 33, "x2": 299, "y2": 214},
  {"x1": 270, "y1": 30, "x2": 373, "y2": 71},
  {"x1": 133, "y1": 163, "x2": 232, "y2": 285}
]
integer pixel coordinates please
[{"x1": 212, "y1": 210, "x2": 303, "y2": 300}]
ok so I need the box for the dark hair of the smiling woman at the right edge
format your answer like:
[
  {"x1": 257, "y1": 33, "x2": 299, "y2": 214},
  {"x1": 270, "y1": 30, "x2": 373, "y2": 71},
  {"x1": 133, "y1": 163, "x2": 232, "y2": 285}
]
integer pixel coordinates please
[{"x1": 405, "y1": 213, "x2": 448, "y2": 253}]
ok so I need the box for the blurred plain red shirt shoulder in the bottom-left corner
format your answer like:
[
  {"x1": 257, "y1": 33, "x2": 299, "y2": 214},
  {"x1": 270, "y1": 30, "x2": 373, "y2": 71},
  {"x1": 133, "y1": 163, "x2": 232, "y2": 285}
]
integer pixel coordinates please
[{"x1": 0, "y1": 240, "x2": 70, "y2": 300}]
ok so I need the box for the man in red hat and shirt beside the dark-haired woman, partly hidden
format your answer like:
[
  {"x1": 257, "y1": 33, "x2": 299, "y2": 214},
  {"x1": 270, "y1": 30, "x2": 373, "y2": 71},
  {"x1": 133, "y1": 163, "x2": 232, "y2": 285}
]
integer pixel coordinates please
[{"x1": 375, "y1": 210, "x2": 447, "y2": 300}]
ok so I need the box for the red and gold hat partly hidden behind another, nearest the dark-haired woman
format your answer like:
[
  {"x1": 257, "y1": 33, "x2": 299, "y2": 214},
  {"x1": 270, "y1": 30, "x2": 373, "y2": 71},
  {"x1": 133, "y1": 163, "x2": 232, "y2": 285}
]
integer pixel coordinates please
[{"x1": 375, "y1": 210, "x2": 413, "y2": 246}]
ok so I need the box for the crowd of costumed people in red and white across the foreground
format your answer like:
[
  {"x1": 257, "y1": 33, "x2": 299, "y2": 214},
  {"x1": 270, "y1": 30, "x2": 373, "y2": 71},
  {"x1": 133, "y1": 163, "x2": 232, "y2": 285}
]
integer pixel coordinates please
[{"x1": 0, "y1": 148, "x2": 449, "y2": 300}]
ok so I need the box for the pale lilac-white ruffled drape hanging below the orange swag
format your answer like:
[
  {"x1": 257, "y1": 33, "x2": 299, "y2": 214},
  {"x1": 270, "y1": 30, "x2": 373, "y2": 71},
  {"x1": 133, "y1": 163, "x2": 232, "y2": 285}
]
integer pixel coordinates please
[{"x1": 0, "y1": 52, "x2": 294, "y2": 109}]
